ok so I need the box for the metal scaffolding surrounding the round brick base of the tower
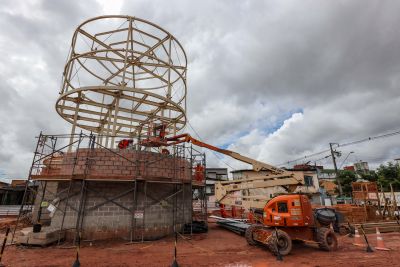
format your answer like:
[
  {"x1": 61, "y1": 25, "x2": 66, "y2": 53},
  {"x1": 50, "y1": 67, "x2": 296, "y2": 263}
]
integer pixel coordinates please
[{"x1": 13, "y1": 132, "x2": 207, "y2": 246}]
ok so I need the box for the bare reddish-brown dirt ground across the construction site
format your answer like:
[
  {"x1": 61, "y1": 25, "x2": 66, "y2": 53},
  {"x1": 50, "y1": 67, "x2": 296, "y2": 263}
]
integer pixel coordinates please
[{"x1": 2, "y1": 225, "x2": 400, "y2": 267}]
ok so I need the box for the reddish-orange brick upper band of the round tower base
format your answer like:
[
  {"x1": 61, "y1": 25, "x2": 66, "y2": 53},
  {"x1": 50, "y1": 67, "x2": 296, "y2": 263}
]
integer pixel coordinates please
[{"x1": 32, "y1": 148, "x2": 192, "y2": 181}]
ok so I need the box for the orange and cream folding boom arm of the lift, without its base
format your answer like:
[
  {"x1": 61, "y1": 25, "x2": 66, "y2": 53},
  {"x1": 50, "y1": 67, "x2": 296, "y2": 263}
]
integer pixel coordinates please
[{"x1": 142, "y1": 131, "x2": 304, "y2": 208}]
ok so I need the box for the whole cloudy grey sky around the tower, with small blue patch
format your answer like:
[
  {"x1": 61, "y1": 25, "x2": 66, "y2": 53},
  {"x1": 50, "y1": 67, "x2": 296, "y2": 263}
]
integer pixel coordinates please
[{"x1": 0, "y1": 0, "x2": 400, "y2": 178}]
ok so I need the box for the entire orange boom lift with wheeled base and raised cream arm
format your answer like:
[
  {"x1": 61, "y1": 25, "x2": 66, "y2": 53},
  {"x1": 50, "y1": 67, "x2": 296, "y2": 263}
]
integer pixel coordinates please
[{"x1": 141, "y1": 125, "x2": 338, "y2": 256}]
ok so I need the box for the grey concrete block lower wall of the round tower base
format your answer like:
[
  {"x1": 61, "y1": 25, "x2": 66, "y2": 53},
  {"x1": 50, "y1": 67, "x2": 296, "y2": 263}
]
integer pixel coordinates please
[{"x1": 51, "y1": 181, "x2": 192, "y2": 240}]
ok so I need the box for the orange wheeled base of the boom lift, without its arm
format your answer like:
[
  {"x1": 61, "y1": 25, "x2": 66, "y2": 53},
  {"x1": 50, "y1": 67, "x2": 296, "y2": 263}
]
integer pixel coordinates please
[{"x1": 245, "y1": 195, "x2": 338, "y2": 256}]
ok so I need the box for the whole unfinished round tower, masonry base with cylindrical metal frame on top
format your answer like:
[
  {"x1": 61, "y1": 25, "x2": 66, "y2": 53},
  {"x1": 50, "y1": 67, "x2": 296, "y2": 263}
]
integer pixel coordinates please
[{"x1": 15, "y1": 16, "x2": 207, "y2": 244}]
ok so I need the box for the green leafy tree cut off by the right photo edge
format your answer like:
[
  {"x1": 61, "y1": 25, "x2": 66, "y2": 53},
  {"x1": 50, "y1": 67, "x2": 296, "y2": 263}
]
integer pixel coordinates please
[{"x1": 376, "y1": 162, "x2": 400, "y2": 191}]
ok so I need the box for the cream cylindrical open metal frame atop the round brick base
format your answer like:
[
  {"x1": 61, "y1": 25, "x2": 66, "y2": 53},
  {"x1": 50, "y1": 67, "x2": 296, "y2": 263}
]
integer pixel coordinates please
[{"x1": 56, "y1": 16, "x2": 187, "y2": 147}]
